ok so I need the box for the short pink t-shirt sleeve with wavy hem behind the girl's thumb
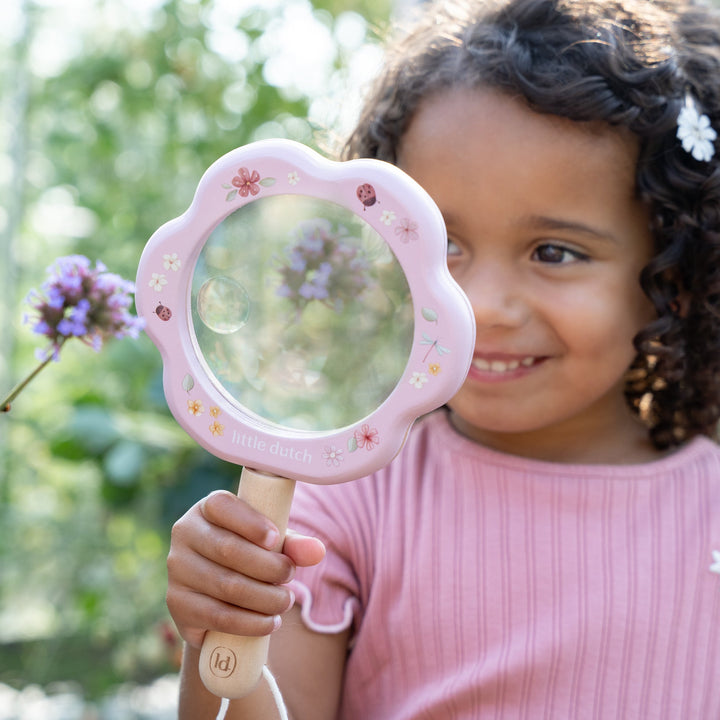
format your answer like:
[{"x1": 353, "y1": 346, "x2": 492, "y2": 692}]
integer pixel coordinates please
[{"x1": 289, "y1": 478, "x2": 372, "y2": 641}]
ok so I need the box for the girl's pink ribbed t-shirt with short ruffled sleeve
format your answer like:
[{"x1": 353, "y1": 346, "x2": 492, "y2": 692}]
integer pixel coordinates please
[{"x1": 291, "y1": 411, "x2": 720, "y2": 720}]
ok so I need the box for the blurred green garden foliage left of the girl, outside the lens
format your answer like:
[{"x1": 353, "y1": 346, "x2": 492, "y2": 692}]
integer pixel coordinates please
[{"x1": 0, "y1": 0, "x2": 397, "y2": 719}]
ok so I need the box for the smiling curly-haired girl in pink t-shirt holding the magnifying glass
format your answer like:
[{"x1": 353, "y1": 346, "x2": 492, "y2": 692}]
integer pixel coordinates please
[{"x1": 168, "y1": 0, "x2": 720, "y2": 720}]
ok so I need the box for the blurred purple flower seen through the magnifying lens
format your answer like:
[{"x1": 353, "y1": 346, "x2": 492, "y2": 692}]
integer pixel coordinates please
[{"x1": 277, "y1": 218, "x2": 370, "y2": 312}]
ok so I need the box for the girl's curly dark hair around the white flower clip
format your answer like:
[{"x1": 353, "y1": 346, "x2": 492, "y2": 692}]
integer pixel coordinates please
[{"x1": 344, "y1": 0, "x2": 720, "y2": 448}]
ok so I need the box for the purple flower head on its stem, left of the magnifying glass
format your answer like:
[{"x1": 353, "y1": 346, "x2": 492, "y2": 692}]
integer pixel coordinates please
[{"x1": 25, "y1": 255, "x2": 144, "y2": 360}]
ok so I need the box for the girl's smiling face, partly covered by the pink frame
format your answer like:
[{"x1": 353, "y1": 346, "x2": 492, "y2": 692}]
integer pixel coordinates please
[{"x1": 399, "y1": 90, "x2": 654, "y2": 462}]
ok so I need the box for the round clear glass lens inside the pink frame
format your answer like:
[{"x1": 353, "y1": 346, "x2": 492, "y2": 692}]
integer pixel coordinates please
[{"x1": 191, "y1": 195, "x2": 413, "y2": 431}]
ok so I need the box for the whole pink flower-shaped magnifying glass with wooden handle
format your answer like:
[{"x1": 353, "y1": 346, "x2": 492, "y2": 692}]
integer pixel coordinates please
[{"x1": 136, "y1": 140, "x2": 475, "y2": 698}]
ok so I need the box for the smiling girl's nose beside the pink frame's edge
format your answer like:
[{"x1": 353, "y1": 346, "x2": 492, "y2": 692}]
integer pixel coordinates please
[{"x1": 459, "y1": 263, "x2": 530, "y2": 328}]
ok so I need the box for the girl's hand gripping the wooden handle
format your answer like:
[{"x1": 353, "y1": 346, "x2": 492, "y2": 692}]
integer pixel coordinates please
[{"x1": 166, "y1": 490, "x2": 325, "y2": 648}]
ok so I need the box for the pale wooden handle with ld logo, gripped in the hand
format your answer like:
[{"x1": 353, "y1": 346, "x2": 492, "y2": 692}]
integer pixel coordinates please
[{"x1": 200, "y1": 468, "x2": 295, "y2": 700}]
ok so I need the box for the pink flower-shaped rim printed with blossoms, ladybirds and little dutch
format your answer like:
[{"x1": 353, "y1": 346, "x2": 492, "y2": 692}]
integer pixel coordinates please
[{"x1": 136, "y1": 140, "x2": 475, "y2": 484}]
